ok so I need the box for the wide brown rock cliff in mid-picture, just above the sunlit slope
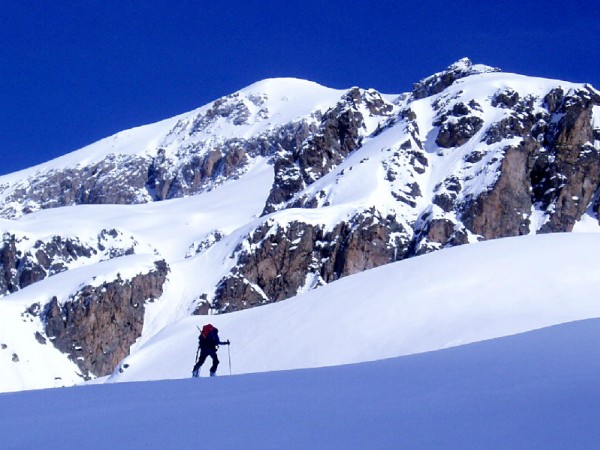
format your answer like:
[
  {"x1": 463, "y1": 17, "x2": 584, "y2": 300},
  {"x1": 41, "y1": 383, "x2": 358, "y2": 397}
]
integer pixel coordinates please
[{"x1": 213, "y1": 212, "x2": 409, "y2": 312}]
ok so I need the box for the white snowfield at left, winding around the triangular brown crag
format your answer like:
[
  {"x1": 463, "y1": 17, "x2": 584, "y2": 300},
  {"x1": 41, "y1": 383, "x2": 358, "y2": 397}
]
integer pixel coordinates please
[{"x1": 0, "y1": 161, "x2": 271, "y2": 392}]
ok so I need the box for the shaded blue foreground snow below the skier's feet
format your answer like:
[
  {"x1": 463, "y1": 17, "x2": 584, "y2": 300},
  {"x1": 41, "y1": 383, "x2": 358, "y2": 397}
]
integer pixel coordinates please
[{"x1": 0, "y1": 319, "x2": 600, "y2": 450}]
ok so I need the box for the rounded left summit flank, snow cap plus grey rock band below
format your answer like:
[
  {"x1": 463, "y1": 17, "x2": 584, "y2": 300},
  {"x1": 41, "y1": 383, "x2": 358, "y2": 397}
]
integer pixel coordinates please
[{"x1": 0, "y1": 78, "x2": 350, "y2": 218}]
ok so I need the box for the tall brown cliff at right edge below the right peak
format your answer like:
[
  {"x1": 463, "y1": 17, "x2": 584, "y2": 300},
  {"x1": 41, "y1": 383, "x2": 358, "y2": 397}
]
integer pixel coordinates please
[{"x1": 460, "y1": 86, "x2": 600, "y2": 239}]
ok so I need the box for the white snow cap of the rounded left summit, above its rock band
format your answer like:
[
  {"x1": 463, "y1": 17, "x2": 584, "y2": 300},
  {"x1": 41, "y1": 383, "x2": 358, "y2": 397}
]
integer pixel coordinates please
[{"x1": 0, "y1": 78, "x2": 345, "y2": 185}]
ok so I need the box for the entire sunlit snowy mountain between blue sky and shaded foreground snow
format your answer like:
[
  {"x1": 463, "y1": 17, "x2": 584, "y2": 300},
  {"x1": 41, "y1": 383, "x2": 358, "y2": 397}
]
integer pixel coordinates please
[{"x1": 0, "y1": 59, "x2": 600, "y2": 391}]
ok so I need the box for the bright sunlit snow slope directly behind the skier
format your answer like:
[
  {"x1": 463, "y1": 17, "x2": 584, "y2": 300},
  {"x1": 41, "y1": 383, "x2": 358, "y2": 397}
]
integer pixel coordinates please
[{"x1": 110, "y1": 233, "x2": 600, "y2": 381}]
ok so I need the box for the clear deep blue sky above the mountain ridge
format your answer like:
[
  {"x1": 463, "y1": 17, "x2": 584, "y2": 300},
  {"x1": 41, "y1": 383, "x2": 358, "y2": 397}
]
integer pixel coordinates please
[{"x1": 0, "y1": 0, "x2": 600, "y2": 173}]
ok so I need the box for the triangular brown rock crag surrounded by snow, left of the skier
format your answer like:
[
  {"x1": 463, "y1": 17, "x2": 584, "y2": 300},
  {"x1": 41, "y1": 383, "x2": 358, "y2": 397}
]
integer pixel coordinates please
[{"x1": 41, "y1": 261, "x2": 168, "y2": 378}]
